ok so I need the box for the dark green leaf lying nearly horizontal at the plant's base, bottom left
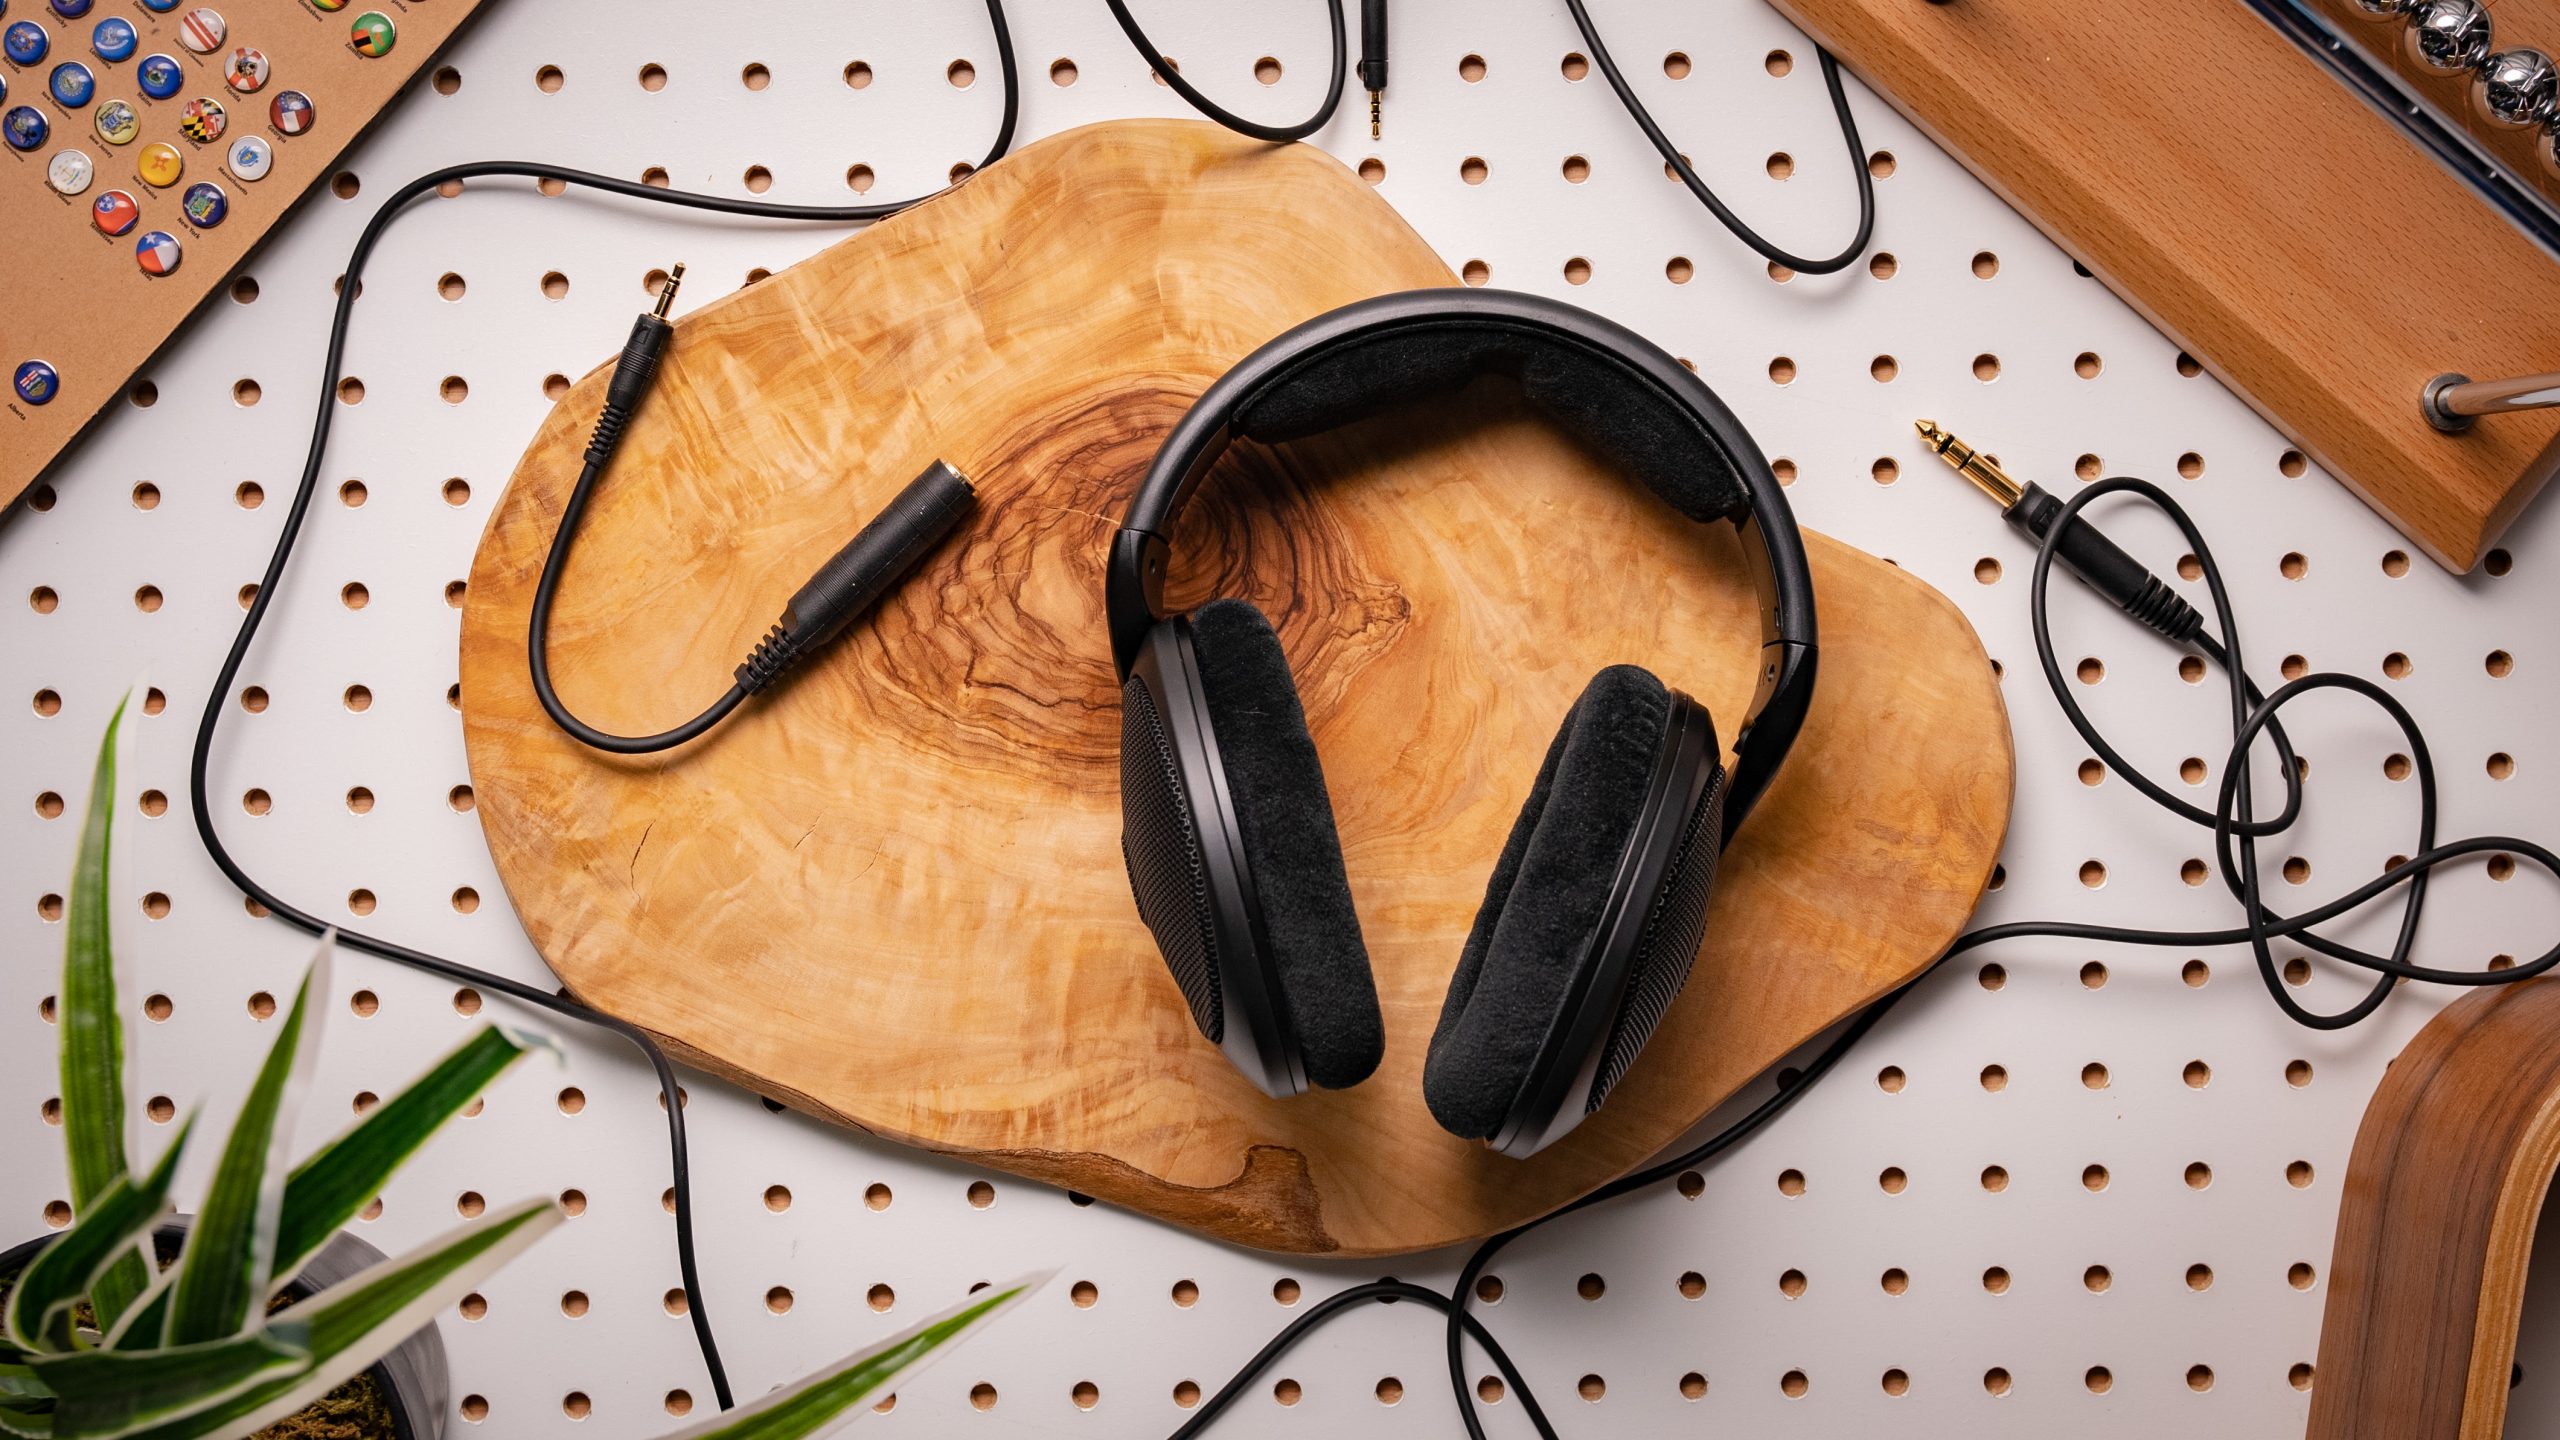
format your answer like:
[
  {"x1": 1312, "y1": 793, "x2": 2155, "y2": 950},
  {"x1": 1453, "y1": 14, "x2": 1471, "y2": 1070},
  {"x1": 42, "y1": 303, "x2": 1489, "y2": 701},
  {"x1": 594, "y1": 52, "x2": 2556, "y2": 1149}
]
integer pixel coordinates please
[{"x1": 28, "y1": 1317, "x2": 312, "y2": 1440}]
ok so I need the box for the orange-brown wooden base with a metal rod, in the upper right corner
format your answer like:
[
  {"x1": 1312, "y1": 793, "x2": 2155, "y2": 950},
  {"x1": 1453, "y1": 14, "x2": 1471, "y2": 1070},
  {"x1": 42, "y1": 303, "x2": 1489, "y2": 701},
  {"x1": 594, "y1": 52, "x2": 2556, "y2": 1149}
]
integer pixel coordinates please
[{"x1": 1774, "y1": 0, "x2": 2560, "y2": 571}]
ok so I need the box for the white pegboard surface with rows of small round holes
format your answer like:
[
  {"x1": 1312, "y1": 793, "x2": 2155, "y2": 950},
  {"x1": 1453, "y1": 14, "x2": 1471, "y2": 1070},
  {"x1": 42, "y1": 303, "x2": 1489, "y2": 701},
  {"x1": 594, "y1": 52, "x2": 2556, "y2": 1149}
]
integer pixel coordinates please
[{"x1": 0, "y1": 0, "x2": 2560, "y2": 1437}]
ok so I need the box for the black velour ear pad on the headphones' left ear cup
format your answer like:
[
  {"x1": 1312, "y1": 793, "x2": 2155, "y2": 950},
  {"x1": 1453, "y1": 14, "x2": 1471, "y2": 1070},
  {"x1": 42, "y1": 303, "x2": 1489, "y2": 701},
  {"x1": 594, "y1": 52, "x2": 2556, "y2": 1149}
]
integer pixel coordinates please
[{"x1": 1190, "y1": 600, "x2": 1388, "y2": 1089}]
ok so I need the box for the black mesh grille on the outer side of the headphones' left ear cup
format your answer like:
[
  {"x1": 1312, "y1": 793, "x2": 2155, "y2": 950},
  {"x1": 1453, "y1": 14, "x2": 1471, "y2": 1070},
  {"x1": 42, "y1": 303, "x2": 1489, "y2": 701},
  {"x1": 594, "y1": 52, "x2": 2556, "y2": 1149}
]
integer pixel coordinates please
[{"x1": 1121, "y1": 676, "x2": 1226, "y2": 1043}]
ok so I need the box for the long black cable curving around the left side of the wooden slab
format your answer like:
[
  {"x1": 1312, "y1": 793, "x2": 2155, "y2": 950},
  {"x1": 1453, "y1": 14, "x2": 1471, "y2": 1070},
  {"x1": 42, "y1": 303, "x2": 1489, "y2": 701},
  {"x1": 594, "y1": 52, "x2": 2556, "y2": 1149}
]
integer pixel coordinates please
[{"x1": 187, "y1": 0, "x2": 1021, "y2": 1409}]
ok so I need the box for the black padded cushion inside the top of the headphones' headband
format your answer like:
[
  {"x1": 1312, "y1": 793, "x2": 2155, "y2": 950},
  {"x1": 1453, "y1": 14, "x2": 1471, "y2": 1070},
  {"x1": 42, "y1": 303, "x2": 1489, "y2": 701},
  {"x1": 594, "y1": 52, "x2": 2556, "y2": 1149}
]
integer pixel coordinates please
[{"x1": 1236, "y1": 318, "x2": 1751, "y2": 520}]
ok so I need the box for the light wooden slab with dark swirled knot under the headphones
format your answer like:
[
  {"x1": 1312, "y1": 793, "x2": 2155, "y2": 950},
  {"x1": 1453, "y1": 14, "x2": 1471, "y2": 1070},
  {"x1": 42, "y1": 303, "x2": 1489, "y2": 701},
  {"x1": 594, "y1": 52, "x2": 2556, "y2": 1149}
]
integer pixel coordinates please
[{"x1": 461, "y1": 120, "x2": 2012, "y2": 1256}]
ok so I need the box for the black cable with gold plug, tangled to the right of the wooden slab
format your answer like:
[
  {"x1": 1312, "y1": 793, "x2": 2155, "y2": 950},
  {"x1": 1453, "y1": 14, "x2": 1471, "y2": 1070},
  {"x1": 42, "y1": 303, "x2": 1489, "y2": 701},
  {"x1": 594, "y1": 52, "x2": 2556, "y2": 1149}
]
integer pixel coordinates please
[{"x1": 1175, "y1": 420, "x2": 2560, "y2": 1440}]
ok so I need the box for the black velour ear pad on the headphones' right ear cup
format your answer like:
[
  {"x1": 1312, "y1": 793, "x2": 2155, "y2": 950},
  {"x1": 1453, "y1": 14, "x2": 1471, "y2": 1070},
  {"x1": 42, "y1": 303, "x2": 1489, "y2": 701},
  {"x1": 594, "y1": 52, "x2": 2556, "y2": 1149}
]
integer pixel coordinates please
[{"x1": 1423, "y1": 666, "x2": 1672, "y2": 1140}]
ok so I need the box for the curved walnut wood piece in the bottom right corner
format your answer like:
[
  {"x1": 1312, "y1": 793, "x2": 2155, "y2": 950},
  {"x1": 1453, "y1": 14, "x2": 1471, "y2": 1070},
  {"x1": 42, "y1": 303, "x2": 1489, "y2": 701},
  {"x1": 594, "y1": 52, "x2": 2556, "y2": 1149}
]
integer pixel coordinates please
[{"x1": 2309, "y1": 979, "x2": 2560, "y2": 1440}]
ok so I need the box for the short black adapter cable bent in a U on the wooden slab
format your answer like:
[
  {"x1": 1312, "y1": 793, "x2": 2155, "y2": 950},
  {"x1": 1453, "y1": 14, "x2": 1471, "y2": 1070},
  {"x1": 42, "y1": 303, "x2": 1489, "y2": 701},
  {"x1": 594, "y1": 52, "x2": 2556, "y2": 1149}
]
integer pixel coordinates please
[{"x1": 525, "y1": 261, "x2": 978, "y2": 756}]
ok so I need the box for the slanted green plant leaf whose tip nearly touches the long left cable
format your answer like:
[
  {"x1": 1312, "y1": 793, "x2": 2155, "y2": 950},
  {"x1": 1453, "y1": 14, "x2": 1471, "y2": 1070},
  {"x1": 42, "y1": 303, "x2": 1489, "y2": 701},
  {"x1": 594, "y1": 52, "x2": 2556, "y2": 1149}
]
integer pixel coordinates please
[{"x1": 269, "y1": 1025, "x2": 561, "y2": 1276}]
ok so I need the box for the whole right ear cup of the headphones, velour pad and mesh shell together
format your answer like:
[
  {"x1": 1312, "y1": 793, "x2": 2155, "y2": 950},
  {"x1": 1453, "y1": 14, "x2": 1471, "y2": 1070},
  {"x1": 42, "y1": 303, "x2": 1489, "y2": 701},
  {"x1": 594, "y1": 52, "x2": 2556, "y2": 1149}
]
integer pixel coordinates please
[{"x1": 1423, "y1": 666, "x2": 1723, "y2": 1153}]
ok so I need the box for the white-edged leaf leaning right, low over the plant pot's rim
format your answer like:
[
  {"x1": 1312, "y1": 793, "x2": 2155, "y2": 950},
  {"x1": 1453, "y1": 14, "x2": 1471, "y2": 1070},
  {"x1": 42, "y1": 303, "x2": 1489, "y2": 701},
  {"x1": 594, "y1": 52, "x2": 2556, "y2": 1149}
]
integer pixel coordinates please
[{"x1": 111, "y1": 1197, "x2": 566, "y2": 1440}]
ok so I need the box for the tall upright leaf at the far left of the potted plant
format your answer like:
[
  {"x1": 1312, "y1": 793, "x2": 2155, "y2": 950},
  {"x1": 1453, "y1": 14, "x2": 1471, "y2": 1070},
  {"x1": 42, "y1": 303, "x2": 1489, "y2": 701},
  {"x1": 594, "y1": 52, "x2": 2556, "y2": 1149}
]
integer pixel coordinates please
[{"x1": 59, "y1": 700, "x2": 151, "y2": 1325}]
